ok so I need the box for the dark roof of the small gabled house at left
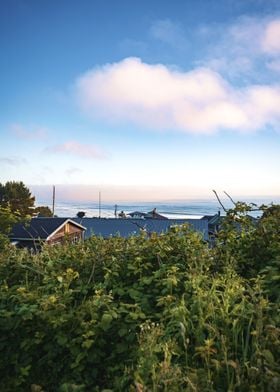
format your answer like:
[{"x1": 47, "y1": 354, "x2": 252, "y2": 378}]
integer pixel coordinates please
[{"x1": 9, "y1": 218, "x2": 85, "y2": 240}]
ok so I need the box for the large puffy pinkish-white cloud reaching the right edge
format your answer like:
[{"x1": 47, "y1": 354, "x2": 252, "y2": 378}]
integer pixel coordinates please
[{"x1": 76, "y1": 58, "x2": 280, "y2": 133}]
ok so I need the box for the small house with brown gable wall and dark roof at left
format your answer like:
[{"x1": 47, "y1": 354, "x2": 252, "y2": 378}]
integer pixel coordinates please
[{"x1": 9, "y1": 218, "x2": 86, "y2": 249}]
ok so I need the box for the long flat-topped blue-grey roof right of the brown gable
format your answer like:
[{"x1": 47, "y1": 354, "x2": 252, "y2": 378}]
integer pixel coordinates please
[{"x1": 72, "y1": 218, "x2": 208, "y2": 240}]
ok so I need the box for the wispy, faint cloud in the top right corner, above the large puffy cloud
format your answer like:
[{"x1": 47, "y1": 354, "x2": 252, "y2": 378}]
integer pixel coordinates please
[{"x1": 196, "y1": 15, "x2": 280, "y2": 79}]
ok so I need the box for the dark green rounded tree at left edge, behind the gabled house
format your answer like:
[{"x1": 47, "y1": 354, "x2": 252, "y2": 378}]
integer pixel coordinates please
[{"x1": 0, "y1": 181, "x2": 35, "y2": 217}]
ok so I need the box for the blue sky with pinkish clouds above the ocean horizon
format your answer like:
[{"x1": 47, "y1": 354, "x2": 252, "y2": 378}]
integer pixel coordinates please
[{"x1": 0, "y1": 0, "x2": 280, "y2": 202}]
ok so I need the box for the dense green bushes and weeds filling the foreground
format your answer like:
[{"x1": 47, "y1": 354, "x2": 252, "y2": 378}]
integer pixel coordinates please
[{"x1": 0, "y1": 205, "x2": 280, "y2": 392}]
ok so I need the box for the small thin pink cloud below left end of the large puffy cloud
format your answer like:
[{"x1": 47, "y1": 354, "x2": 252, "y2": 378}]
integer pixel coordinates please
[{"x1": 45, "y1": 140, "x2": 105, "y2": 159}]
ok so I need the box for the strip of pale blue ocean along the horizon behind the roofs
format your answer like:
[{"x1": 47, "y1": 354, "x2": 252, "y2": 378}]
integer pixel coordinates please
[{"x1": 36, "y1": 197, "x2": 280, "y2": 219}]
